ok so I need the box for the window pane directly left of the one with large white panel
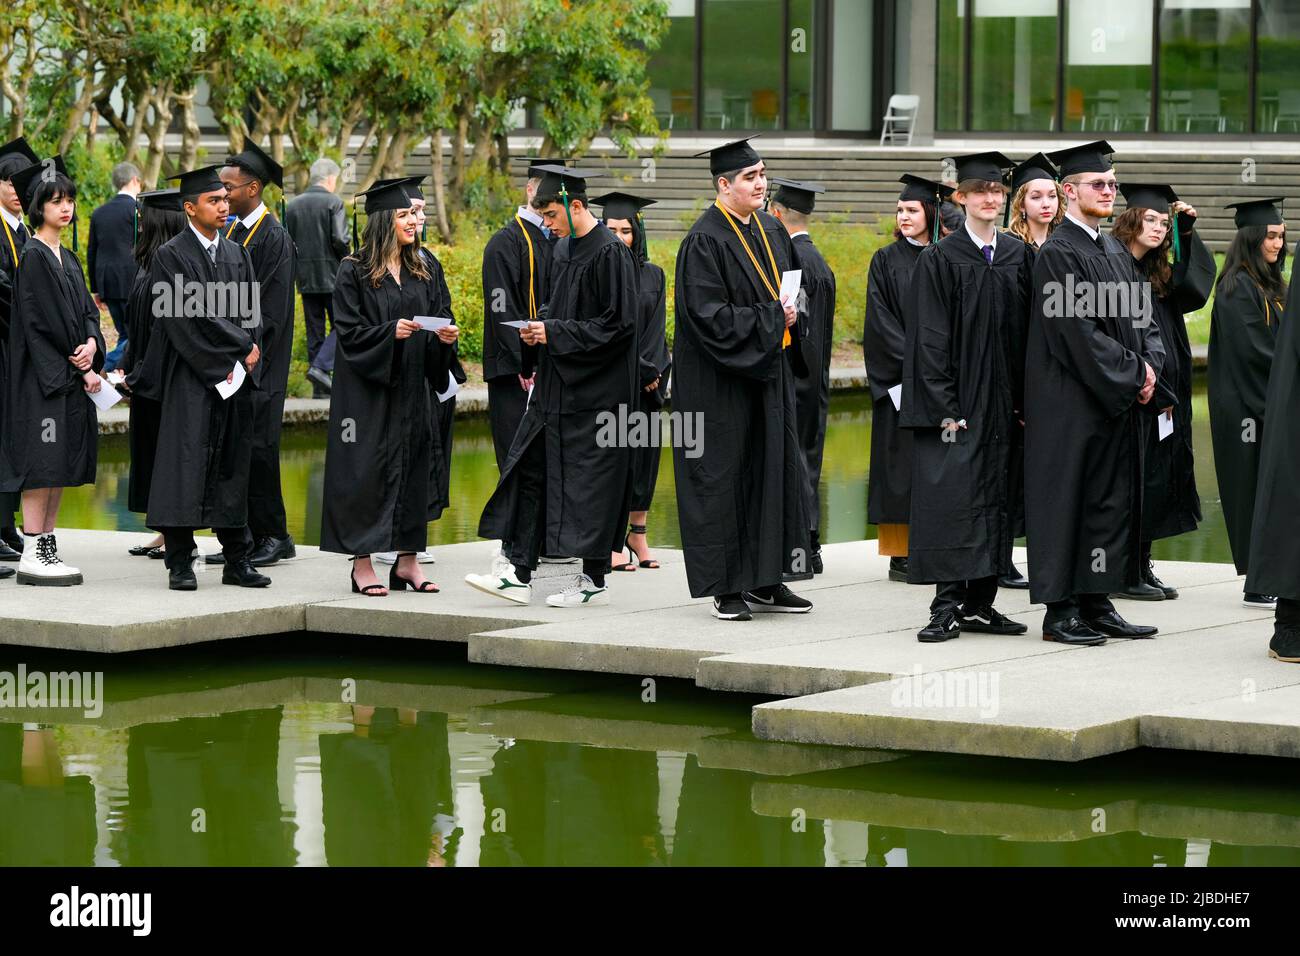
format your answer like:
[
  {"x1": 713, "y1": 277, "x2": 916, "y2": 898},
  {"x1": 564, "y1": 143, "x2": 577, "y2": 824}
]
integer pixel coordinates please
[{"x1": 971, "y1": 0, "x2": 1057, "y2": 130}]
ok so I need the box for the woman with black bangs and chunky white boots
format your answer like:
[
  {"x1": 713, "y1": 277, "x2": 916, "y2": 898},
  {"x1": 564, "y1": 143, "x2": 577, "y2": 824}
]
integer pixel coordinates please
[{"x1": 0, "y1": 156, "x2": 104, "y2": 587}]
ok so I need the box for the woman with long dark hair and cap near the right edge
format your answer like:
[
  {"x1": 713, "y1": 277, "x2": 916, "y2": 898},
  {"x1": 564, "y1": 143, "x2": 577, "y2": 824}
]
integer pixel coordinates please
[{"x1": 1208, "y1": 198, "x2": 1287, "y2": 609}]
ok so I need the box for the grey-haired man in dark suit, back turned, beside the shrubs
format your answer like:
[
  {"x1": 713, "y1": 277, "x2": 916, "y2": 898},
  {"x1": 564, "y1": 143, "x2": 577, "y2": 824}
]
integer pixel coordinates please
[{"x1": 285, "y1": 156, "x2": 348, "y2": 398}]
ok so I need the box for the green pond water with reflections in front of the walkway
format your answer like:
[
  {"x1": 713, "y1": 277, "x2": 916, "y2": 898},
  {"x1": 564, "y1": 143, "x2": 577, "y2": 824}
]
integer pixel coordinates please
[{"x1": 0, "y1": 636, "x2": 1300, "y2": 866}]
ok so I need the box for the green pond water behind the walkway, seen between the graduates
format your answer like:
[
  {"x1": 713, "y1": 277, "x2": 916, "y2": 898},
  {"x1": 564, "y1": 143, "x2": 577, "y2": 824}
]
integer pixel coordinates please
[{"x1": 59, "y1": 385, "x2": 1231, "y2": 564}]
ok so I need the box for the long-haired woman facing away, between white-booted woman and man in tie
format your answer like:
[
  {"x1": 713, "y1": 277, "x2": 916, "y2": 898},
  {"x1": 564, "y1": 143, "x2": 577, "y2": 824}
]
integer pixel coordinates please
[{"x1": 121, "y1": 189, "x2": 187, "y2": 558}]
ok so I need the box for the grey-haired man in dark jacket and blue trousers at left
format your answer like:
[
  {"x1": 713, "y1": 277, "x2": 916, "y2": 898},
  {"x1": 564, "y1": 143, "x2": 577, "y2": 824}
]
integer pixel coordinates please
[{"x1": 86, "y1": 163, "x2": 140, "y2": 375}]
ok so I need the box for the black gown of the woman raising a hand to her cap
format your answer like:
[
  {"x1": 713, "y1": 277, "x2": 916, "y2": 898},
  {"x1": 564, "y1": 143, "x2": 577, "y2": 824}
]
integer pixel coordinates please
[{"x1": 1141, "y1": 213, "x2": 1214, "y2": 541}]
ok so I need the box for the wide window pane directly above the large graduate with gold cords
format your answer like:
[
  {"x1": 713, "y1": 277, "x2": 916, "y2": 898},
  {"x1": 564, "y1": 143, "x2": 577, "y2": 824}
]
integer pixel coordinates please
[{"x1": 703, "y1": 0, "x2": 784, "y2": 130}]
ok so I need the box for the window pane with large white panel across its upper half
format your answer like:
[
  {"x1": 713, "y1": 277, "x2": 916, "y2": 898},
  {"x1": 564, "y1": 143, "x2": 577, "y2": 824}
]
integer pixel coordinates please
[{"x1": 1063, "y1": 0, "x2": 1153, "y2": 133}]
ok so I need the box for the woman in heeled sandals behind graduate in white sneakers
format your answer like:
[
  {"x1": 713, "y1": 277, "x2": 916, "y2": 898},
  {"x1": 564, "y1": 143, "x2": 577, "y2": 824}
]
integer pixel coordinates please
[{"x1": 592, "y1": 193, "x2": 672, "y2": 571}]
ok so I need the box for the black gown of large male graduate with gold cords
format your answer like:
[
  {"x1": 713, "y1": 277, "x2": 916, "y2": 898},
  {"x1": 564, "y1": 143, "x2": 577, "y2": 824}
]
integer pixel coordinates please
[{"x1": 672, "y1": 206, "x2": 811, "y2": 597}]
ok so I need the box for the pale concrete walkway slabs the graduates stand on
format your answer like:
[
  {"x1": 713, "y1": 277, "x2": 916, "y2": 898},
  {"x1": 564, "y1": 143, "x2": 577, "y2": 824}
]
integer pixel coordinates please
[{"x1": 0, "y1": 531, "x2": 1300, "y2": 761}]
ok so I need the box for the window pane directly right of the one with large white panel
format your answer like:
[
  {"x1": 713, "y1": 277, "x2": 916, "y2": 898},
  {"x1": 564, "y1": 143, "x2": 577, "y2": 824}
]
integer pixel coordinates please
[{"x1": 1160, "y1": 0, "x2": 1251, "y2": 133}]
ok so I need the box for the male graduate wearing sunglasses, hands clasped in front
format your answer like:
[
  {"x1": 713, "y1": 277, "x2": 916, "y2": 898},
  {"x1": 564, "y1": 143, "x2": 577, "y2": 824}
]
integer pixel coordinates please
[{"x1": 1024, "y1": 140, "x2": 1165, "y2": 645}]
